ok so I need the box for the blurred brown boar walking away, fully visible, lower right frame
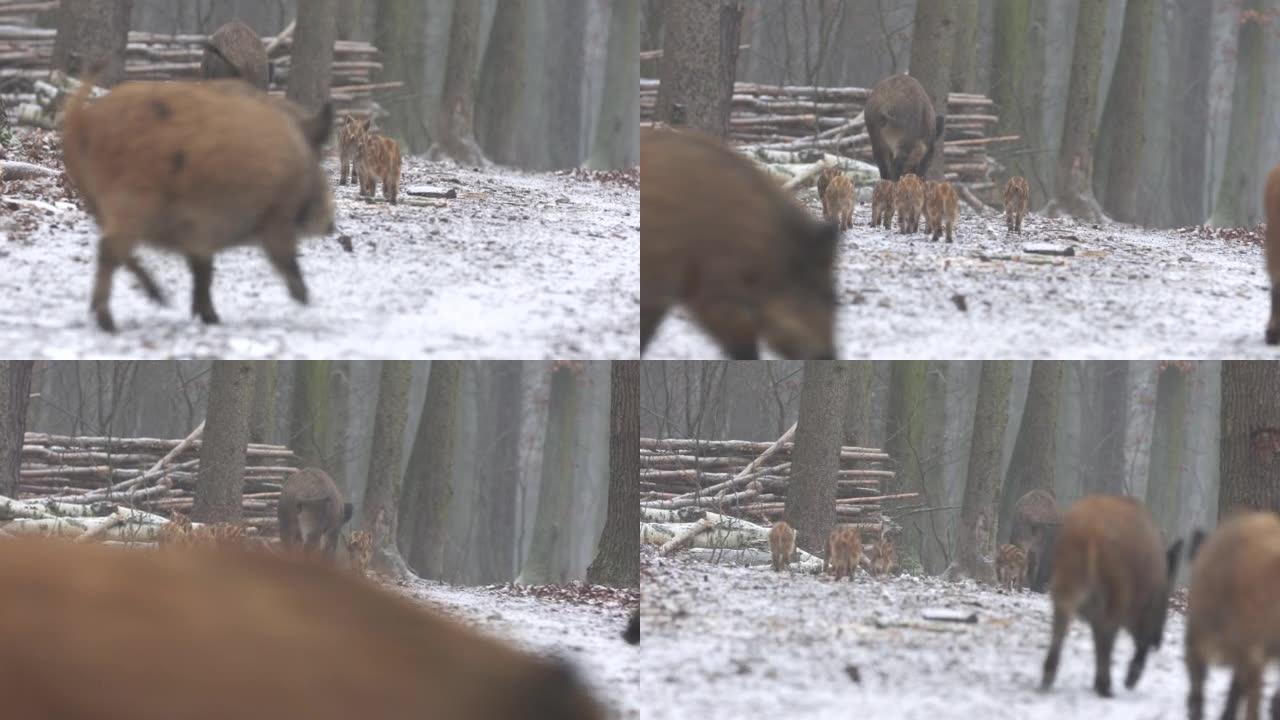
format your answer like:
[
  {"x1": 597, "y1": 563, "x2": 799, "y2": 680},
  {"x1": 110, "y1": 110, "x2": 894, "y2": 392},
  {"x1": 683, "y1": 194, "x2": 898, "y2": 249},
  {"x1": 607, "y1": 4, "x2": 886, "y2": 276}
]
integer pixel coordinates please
[{"x1": 1041, "y1": 495, "x2": 1183, "y2": 697}]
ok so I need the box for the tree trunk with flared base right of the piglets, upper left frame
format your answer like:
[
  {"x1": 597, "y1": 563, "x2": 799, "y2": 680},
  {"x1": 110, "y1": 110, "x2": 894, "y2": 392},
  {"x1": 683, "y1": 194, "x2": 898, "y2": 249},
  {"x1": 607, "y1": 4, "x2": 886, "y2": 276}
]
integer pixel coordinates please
[{"x1": 434, "y1": 0, "x2": 485, "y2": 165}]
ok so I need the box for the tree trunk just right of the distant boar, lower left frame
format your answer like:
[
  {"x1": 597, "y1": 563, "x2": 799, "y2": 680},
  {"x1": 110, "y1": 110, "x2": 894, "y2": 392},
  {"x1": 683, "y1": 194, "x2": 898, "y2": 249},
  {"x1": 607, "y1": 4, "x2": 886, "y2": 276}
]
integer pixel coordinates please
[{"x1": 360, "y1": 360, "x2": 413, "y2": 578}]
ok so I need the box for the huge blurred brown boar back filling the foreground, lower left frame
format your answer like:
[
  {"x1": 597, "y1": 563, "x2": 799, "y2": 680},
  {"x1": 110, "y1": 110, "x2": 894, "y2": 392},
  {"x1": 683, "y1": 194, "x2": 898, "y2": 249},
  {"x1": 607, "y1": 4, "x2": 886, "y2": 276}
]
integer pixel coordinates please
[{"x1": 0, "y1": 539, "x2": 604, "y2": 720}]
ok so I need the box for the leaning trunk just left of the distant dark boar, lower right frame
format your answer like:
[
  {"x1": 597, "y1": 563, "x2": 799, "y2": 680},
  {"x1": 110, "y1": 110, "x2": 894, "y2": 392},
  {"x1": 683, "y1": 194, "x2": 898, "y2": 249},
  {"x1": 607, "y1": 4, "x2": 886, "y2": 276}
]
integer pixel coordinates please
[{"x1": 998, "y1": 360, "x2": 1062, "y2": 539}]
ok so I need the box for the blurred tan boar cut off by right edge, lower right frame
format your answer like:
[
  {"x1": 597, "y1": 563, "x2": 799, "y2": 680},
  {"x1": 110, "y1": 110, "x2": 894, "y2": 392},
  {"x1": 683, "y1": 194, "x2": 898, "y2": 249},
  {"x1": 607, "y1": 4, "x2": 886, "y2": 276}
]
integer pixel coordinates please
[{"x1": 1185, "y1": 512, "x2": 1280, "y2": 720}]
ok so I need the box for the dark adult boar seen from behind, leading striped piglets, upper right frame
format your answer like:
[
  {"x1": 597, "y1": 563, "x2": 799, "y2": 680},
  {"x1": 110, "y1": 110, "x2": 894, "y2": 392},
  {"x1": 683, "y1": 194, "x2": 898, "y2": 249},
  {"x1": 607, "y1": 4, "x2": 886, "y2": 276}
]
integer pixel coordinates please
[{"x1": 863, "y1": 74, "x2": 946, "y2": 181}]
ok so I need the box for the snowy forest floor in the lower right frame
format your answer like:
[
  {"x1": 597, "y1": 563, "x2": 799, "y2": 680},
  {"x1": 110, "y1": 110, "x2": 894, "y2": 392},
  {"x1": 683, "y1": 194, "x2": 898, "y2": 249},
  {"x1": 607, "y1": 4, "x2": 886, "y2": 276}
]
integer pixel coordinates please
[{"x1": 640, "y1": 553, "x2": 1259, "y2": 720}]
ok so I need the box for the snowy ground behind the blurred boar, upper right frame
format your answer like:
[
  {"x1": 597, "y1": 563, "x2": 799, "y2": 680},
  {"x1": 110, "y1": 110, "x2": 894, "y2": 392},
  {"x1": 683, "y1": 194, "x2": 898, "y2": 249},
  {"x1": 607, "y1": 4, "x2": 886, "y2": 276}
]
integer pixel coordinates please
[{"x1": 645, "y1": 181, "x2": 1280, "y2": 360}]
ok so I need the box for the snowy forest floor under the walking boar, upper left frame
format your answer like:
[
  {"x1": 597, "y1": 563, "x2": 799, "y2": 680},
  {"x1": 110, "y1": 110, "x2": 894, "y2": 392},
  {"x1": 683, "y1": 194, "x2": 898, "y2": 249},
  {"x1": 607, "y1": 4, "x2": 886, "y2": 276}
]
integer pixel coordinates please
[{"x1": 0, "y1": 128, "x2": 640, "y2": 359}]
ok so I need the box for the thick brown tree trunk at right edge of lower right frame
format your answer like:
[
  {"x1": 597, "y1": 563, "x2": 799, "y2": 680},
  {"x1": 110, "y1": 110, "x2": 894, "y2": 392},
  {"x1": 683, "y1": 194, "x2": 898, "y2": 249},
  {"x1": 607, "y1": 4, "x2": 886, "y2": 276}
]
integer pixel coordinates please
[{"x1": 1217, "y1": 360, "x2": 1280, "y2": 519}]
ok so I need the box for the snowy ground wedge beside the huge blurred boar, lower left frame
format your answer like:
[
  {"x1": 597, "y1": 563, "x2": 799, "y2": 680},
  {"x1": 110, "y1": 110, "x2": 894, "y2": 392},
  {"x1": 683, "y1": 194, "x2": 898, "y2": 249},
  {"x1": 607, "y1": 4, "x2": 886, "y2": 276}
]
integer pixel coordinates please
[{"x1": 392, "y1": 568, "x2": 648, "y2": 720}]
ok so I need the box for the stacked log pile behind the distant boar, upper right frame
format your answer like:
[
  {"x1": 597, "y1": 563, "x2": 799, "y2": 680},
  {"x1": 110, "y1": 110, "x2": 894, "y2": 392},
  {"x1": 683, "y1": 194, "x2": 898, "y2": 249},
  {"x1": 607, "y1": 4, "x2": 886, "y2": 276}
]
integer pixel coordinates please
[{"x1": 640, "y1": 78, "x2": 1019, "y2": 192}]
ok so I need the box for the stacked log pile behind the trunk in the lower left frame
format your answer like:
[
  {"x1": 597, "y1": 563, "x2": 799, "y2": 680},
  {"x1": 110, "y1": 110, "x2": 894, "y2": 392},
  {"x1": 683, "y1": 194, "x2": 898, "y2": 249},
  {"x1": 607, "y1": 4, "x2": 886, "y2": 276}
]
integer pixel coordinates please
[{"x1": 0, "y1": 425, "x2": 300, "y2": 539}]
